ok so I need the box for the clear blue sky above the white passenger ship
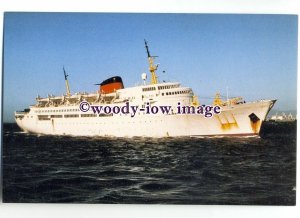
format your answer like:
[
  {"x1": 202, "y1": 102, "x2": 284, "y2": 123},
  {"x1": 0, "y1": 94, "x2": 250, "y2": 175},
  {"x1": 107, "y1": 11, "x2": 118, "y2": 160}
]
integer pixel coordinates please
[{"x1": 3, "y1": 13, "x2": 298, "y2": 122}]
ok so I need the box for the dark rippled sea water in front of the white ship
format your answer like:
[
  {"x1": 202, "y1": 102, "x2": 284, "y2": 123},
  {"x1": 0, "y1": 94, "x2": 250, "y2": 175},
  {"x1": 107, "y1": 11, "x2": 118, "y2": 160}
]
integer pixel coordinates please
[{"x1": 2, "y1": 122, "x2": 296, "y2": 205}]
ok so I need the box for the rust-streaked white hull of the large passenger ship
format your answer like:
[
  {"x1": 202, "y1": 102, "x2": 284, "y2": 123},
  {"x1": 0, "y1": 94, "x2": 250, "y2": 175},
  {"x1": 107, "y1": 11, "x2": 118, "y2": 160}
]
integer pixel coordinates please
[{"x1": 16, "y1": 100, "x2": 275, "y2": 137}]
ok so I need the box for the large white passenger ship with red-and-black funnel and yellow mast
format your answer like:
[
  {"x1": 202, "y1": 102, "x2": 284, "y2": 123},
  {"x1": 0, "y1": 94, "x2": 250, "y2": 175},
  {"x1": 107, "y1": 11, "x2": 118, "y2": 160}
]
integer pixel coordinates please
[{"x1": 15, "y1": 40, "x2": 276, "y2": 138}]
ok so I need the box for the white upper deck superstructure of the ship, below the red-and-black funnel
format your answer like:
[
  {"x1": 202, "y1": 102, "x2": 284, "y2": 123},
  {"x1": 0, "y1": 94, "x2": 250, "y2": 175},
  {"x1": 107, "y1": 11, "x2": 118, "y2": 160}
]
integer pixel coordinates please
[{"x1": 34, "y1": 82, "x2": 193, "y2": 107}]
